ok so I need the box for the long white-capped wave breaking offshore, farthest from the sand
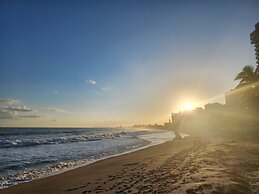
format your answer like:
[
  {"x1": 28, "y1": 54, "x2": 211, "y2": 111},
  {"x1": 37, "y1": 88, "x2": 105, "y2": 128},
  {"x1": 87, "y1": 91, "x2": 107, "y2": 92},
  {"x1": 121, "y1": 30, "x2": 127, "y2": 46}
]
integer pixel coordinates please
[{"x1": 0, "y1": 132, "x2": 126, "y2": 149}]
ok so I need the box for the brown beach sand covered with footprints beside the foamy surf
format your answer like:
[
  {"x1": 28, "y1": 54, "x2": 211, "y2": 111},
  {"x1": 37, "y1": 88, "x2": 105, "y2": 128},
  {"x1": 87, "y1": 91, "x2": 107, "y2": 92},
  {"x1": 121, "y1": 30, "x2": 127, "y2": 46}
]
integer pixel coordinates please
[{"x1": 0, "y1": 138, "x2": 259, "y2": 194}]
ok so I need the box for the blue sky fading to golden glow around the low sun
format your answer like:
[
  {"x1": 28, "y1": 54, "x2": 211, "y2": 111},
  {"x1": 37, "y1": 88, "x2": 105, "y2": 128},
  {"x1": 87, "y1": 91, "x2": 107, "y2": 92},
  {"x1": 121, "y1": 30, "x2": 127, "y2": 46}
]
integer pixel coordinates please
[{"x1": 0, "y1": 0, "x2": 259, "y2": 127}]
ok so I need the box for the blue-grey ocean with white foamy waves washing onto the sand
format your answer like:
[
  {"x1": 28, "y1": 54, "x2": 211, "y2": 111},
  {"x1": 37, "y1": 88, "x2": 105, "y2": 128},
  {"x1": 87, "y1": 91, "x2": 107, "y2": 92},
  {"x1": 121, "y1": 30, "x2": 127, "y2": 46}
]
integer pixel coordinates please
[{"x1": 0, "y1": 128, "x2": 175, "y2": 189}]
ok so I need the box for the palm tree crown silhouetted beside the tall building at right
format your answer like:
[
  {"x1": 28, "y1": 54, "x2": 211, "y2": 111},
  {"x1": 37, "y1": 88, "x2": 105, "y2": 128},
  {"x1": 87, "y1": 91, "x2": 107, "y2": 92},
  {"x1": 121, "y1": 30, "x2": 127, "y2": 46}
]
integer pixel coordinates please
[{"x1": 235, "y1": 65, "x2": 259, "y2": 88}]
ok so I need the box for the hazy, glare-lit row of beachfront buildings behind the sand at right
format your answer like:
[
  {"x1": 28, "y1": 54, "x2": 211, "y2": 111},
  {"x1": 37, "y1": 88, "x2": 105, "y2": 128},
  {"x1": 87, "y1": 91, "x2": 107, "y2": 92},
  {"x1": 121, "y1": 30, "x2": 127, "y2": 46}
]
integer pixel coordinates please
[{"x1": 170, "y1": 22, "x2": 259, "y2": 136}]
